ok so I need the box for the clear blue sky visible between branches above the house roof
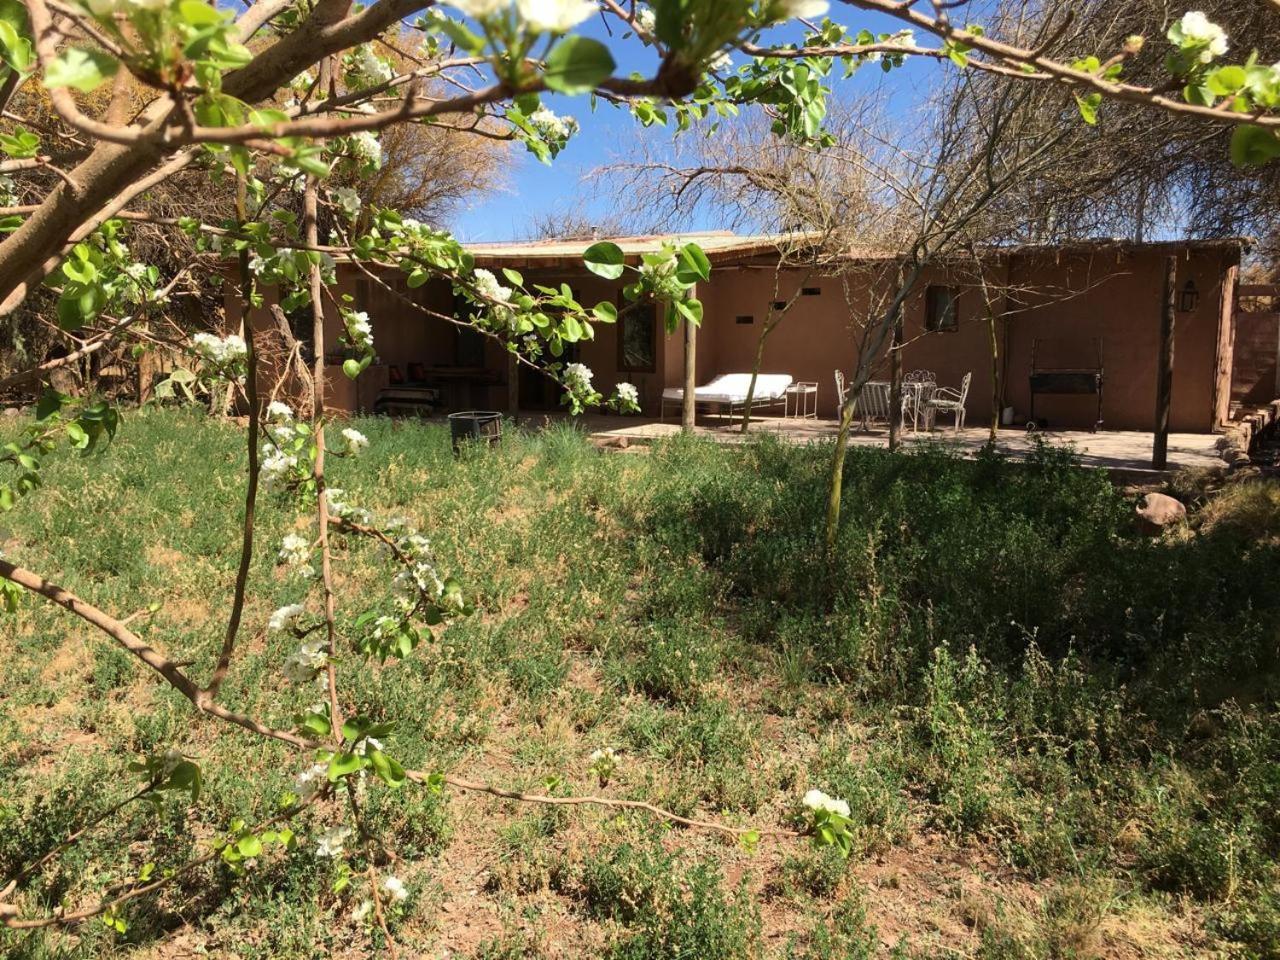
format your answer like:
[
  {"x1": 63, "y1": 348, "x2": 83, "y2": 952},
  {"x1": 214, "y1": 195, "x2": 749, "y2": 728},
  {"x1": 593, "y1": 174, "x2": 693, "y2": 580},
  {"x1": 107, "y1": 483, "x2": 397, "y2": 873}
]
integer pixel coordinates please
[{"x1": 449, "y1": 10, "x2": 940, "y2": 243}]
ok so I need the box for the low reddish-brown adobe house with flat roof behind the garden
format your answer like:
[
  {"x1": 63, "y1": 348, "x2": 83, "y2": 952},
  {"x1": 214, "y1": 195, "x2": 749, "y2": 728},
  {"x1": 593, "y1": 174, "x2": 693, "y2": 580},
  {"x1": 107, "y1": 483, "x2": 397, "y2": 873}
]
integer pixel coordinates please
[{"x1": 228, "y1": 233, "x2": 1244, "y2": 433}]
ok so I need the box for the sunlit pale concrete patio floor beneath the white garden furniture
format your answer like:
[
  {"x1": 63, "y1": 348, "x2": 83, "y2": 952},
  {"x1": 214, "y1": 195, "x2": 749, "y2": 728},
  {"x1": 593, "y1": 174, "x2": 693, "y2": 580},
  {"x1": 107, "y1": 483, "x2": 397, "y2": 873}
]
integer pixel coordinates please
[{"x1": 565, "y1": 415, "x2": 1225, "y2": 480}]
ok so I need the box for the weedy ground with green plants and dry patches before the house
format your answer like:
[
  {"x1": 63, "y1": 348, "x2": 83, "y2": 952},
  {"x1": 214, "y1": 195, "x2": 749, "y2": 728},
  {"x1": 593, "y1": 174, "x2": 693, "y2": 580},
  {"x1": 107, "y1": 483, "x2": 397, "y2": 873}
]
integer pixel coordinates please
[{"x1": 0, "y1": 411, "x2": 1280, "y2": 960}]
